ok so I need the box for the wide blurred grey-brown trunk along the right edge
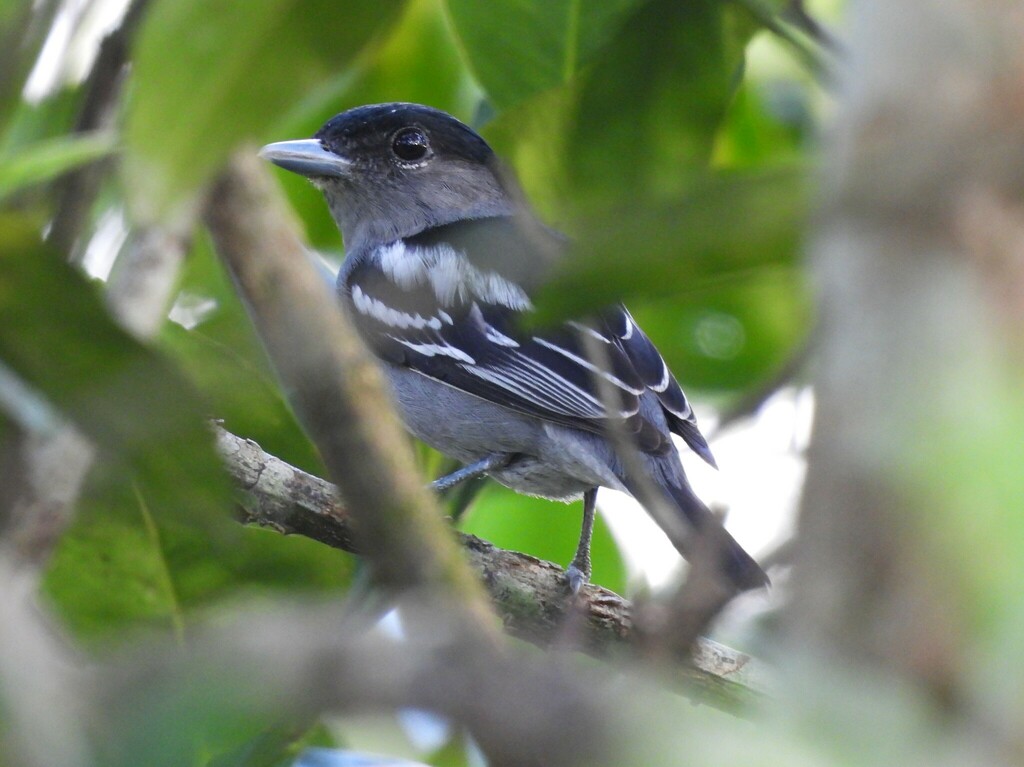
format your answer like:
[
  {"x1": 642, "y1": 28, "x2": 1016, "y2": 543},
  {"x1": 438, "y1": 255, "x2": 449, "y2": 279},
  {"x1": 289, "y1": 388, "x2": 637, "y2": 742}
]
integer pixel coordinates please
[{"x1": 791, "y1": 0, "x2": 1024, "y2": 763}]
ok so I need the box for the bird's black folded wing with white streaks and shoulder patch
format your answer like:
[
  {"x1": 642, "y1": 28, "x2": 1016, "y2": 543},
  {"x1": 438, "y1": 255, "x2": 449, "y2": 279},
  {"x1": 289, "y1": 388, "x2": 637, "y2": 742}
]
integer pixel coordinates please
[{"x1": 340, "y1": 219, "x2": 714, "y2": 465}]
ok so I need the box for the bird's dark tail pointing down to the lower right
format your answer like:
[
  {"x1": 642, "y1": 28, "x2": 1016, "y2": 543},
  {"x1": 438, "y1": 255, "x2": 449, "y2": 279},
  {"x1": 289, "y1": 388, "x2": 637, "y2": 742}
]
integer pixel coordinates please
[{"x1": 627, "y1": 477, "x2": 770, "y2": 591}]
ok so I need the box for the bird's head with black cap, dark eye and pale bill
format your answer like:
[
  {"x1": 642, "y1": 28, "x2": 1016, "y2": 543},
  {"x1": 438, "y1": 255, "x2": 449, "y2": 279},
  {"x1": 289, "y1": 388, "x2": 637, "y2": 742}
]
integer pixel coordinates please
[{"x1": 260, "y1": 103, "x2": 514, "y2": 249}]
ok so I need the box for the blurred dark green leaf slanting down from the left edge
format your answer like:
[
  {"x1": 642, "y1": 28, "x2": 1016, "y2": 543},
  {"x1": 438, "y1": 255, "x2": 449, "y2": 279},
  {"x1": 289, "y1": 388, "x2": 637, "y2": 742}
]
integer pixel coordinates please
[{"x1": 0, "y1": 217, "x2": 230, "y2": 525}]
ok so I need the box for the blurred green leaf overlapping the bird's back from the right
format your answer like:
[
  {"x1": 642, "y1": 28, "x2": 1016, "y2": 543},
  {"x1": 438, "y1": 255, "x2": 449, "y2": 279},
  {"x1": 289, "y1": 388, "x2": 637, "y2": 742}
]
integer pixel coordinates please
[{"x1": 538, "y1": 169, "x2": 807, "y2": 322}]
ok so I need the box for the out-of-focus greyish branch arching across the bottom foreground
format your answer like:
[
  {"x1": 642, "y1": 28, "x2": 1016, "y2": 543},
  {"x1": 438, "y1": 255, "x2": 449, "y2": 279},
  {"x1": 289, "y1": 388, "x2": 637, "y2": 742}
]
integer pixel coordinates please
[{"x1": 95, "y1": 598, "x2": 614, "y2": 767}]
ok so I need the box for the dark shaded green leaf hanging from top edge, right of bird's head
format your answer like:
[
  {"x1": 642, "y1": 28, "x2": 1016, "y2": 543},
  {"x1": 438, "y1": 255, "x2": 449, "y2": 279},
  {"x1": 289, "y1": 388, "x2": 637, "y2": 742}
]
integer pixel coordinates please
[{"x1": 568, "y1": 0, "x2": 742, "y2": 207}]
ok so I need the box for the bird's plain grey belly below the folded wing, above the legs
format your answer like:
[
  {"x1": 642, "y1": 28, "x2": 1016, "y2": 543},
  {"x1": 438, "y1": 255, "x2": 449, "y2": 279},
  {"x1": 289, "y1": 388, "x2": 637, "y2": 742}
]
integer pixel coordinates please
[{"x1": 384, "y1": 367, "x2": 623, "y2": 501}]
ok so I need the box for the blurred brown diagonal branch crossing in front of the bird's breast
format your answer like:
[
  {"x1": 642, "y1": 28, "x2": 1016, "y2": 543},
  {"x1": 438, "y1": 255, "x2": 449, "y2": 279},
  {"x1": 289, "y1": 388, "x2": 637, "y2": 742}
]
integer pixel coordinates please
[{"x1": 205, "y1": 150, "x2": 497, "y2": 639}]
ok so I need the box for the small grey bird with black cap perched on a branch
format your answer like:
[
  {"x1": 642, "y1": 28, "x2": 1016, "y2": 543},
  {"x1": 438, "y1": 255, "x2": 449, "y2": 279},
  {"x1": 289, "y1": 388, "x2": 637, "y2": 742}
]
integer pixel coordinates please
[{"x1": 260, "y1": 102, "x2": 768, "y2": 593}]
